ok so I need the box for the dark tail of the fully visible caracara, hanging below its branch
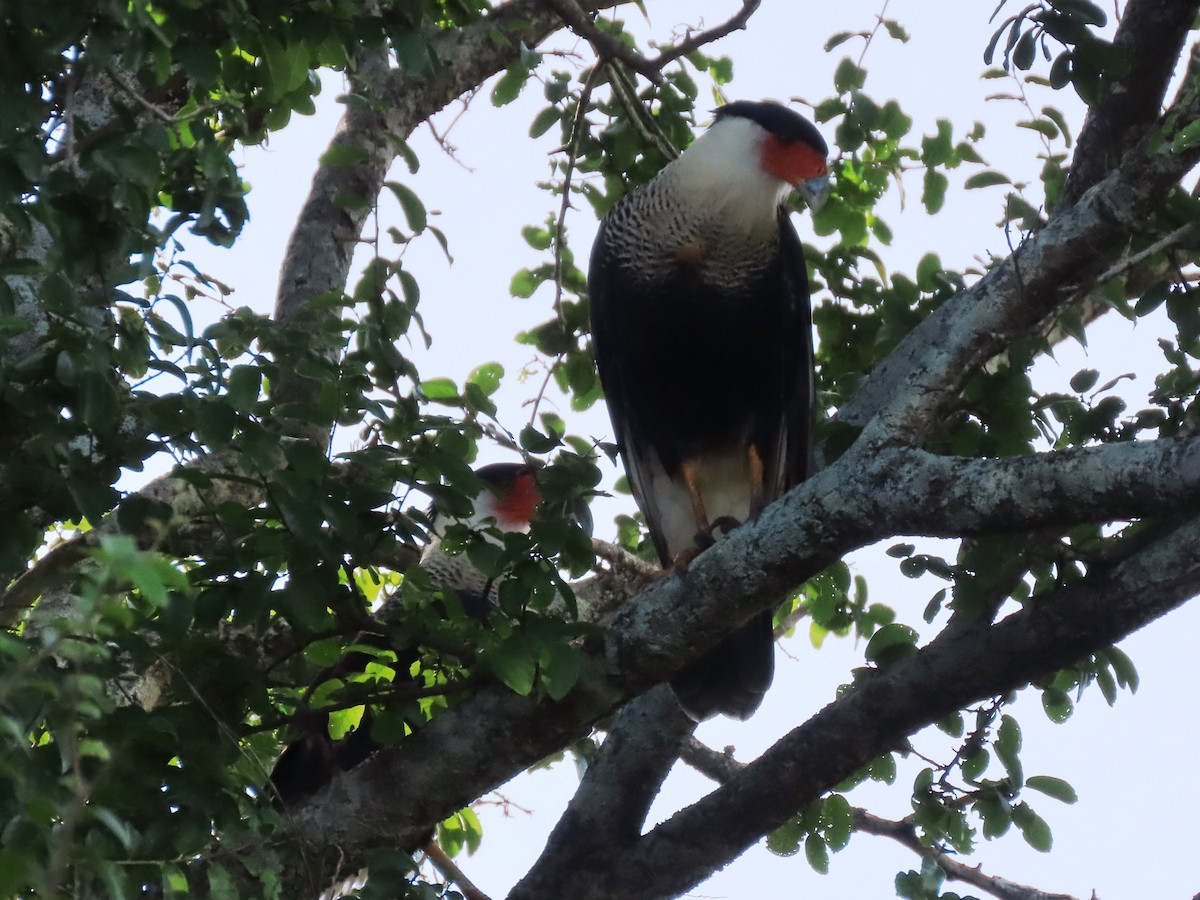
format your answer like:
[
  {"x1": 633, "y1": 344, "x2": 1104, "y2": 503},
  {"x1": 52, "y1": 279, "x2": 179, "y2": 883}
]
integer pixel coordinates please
[{"x1": 671, "y1": 610, "x2": 775, "y2": 721}]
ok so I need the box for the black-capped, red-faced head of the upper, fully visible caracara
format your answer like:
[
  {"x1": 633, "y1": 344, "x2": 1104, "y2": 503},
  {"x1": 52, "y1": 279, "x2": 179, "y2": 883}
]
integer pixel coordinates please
[{"x1": 709, "y1": 100, "x2": 829, "y2": 210}]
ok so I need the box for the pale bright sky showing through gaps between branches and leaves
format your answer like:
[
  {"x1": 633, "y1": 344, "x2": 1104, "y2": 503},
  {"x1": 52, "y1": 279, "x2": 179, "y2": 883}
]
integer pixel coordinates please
[{"x1": 164, "y1": 0, "x2": 1200, "y2": 900}]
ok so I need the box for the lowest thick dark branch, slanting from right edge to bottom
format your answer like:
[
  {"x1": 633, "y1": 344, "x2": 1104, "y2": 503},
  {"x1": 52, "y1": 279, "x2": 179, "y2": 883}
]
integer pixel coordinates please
[{"x1": 523, "y1": 521, "x2": 1200, "y2": 900}]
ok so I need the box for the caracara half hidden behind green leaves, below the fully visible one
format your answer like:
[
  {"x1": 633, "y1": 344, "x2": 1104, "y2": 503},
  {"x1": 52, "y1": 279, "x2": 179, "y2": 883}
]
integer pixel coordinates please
[{"x1": 270, "y1": 462, "x2": 541, "y2": 806}]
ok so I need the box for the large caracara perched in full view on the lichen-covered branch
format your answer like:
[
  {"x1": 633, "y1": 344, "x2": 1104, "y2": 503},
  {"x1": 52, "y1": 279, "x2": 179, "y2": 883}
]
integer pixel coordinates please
[{"x1": 588, "y1": 101, "x2": 829, "y2": 720}]
